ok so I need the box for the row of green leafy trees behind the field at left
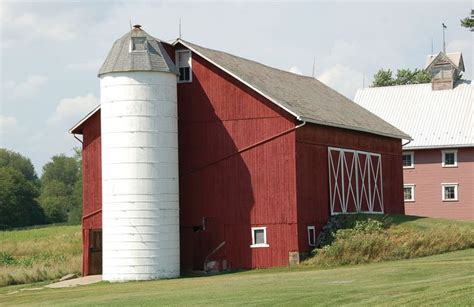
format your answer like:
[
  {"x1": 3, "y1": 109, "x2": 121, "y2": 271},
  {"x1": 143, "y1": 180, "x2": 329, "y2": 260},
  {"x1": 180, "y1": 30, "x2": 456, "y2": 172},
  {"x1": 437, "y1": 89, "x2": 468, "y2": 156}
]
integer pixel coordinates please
[{"x1": 0, "y1": 148, "x2": 82, "y2": 229}]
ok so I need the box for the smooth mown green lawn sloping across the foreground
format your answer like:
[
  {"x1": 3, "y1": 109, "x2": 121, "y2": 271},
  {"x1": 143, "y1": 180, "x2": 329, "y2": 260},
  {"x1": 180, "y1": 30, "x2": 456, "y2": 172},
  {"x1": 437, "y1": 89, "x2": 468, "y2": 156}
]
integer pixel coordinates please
[{"x1": 0, "y1": 249, "x2": 474, "y2": 306}]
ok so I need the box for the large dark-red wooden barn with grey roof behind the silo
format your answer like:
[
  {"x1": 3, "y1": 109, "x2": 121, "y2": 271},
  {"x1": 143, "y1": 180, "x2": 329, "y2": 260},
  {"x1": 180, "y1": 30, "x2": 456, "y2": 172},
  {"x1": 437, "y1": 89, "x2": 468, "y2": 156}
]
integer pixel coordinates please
[{"x1": 71, "y1": 28, "x2": 410, "y2": 275}]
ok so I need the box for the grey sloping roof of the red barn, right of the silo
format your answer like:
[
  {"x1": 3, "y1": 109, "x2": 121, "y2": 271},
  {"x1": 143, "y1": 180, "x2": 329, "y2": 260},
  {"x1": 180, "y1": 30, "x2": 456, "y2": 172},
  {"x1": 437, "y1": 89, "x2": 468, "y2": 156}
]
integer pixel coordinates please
[{"x1": 174, "y1": 39, "x2": 411, "y2": 139}]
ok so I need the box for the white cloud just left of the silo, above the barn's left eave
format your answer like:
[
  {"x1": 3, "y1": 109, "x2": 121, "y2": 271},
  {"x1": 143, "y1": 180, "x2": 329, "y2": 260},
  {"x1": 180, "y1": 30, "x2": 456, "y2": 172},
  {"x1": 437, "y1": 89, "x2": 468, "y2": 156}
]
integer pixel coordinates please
[{"x1": 48, "y1": 94, "x2": 99, "y2": 124}]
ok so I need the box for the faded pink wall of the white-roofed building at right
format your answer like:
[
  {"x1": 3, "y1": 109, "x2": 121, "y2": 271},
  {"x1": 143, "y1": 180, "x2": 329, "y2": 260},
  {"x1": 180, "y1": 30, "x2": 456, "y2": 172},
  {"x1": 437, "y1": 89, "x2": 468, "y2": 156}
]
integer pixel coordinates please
[{"x1": 403, "y1": 147, "x2": 474, "y2": 220}]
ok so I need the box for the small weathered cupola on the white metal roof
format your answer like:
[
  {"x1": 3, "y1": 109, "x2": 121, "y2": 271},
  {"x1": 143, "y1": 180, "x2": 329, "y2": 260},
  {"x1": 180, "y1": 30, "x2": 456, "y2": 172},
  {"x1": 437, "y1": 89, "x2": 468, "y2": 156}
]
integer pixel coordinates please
[{"x1": 425, "y1": 52, "x2": 464, "y2": 91}]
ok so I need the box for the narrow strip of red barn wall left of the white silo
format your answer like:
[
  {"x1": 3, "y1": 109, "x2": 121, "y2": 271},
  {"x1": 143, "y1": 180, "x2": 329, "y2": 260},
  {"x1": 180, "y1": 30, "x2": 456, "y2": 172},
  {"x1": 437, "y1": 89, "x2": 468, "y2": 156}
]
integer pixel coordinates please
[{"x1": 82, "y1": 111, "x2": 102, "y2": 276}]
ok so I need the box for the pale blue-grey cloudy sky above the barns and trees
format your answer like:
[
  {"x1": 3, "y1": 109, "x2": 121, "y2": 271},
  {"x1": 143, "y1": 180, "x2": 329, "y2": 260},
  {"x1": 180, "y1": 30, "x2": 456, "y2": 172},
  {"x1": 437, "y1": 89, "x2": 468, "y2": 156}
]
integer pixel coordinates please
[{"x1": 0, "y1": 0, "x2": 472, "y2": 174}]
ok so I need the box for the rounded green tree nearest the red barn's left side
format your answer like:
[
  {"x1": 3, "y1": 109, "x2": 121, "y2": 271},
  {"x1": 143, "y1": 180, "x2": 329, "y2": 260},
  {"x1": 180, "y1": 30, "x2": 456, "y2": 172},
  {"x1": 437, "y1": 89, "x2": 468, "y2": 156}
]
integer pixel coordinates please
[{"x1": 39, "y1": 154, "x2": 80, "y2": 223}]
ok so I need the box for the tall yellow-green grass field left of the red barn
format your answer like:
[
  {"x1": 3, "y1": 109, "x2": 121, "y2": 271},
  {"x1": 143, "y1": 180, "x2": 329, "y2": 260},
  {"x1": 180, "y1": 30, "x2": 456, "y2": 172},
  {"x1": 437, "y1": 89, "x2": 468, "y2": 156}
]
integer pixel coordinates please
[{"x1": 0, "y1": 225, "x2": 82, "y2": 286}]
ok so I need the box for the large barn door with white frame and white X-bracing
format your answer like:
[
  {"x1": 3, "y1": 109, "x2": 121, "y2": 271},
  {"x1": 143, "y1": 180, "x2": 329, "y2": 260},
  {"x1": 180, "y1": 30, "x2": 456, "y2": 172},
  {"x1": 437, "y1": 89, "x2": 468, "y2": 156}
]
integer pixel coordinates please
[{"x1": 328, "y1": 147, "x2": 384, "y2": 215}]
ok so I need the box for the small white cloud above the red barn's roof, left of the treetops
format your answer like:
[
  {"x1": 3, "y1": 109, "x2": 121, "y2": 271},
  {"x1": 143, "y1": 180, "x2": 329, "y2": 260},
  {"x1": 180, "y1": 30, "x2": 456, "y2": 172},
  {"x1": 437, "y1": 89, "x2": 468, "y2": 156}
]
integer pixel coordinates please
[{"x1": 317, "y1": 64, "x2": 364, "y2": 99}]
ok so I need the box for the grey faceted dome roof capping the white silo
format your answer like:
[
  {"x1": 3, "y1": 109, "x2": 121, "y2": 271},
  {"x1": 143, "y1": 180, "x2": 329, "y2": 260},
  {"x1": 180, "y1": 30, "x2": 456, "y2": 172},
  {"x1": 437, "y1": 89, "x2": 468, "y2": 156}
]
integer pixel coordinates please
[{"x1": 98, "y1": 25, "x2": 178, "y2": 76}]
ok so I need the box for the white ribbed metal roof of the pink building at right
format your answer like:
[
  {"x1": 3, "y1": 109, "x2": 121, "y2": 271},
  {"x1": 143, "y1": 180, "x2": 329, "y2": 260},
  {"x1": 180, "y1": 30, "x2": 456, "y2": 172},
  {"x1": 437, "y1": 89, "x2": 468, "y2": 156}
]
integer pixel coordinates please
[{"x1": 354, "y1": 81, "x2": 474, "y2": 149}]
